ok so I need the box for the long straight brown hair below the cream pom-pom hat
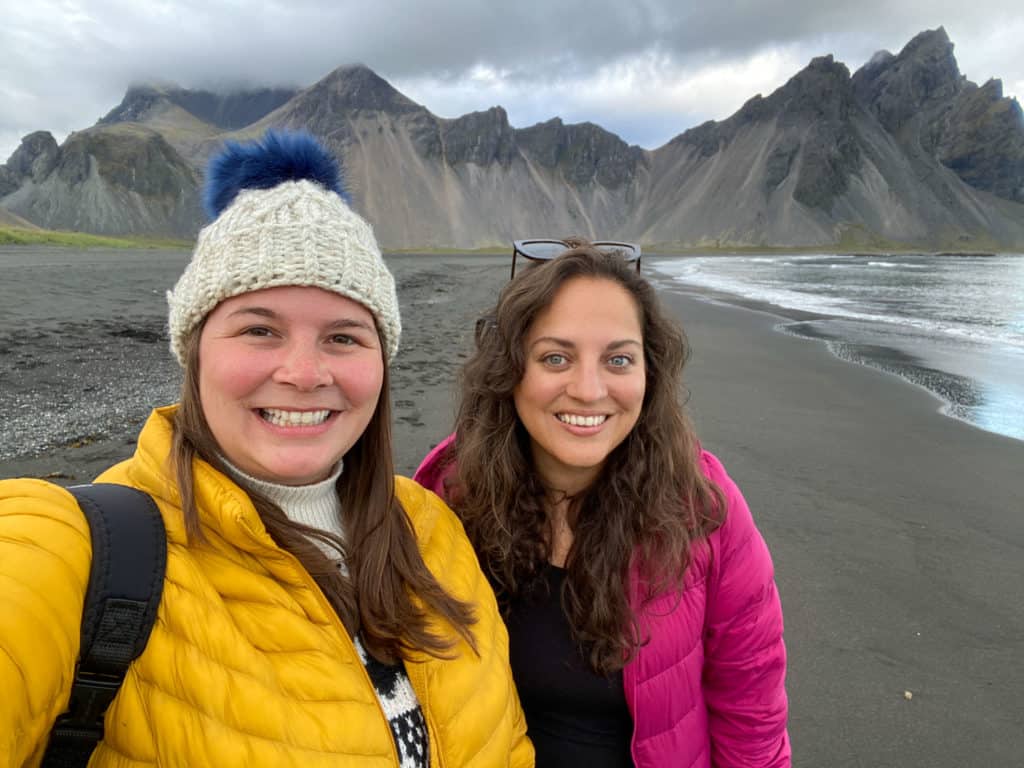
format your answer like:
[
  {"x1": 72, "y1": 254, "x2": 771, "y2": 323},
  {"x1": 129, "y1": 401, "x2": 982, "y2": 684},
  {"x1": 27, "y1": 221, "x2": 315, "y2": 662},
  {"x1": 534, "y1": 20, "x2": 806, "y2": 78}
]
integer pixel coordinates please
[{"x1": 171, "y1": 323, "x2": 476, "y2": 664}]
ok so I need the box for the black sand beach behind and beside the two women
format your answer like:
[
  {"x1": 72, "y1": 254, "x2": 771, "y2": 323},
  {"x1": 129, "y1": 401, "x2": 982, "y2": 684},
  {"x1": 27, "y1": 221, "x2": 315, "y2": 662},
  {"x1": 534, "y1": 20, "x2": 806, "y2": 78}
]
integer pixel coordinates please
[{"x1": 0, "y1": 252, "x2": 1024, "y2": 768}]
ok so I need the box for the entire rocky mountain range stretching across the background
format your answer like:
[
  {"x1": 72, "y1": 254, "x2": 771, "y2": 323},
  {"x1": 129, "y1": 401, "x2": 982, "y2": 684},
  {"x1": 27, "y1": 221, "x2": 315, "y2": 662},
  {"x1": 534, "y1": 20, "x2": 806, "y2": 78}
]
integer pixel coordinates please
[{"x1": 0, "y1": 28, "x2": 1024, "y2": 251}]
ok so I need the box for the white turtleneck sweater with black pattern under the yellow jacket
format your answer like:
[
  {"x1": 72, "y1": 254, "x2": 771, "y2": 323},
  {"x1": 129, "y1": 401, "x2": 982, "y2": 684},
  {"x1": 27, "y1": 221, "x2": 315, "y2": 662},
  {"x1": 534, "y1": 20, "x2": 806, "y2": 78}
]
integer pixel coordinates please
[{"x1": 221, "y1": 457, "x2": 430, "y2": 768}]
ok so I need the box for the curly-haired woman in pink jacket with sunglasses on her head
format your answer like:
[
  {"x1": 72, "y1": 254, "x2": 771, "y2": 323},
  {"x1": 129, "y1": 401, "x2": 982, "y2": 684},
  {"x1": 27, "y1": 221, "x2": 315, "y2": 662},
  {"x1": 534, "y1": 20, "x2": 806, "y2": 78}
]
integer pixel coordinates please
[{"x1": 417, "y1": 243, "x2": 791, "y2": 768}]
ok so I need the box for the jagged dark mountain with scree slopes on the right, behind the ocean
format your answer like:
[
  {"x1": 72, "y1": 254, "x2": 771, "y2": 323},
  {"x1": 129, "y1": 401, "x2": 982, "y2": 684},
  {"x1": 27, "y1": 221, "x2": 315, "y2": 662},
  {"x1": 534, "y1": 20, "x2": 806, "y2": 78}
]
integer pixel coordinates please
[{"x1": 636, "y1": 29, "x2": 1024, "y2": 249}]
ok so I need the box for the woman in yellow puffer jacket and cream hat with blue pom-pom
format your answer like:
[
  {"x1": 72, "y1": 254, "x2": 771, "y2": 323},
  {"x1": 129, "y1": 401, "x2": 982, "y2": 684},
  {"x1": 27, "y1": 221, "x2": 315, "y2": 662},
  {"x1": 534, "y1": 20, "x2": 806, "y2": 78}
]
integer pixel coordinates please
[{"x1": 0, "y1": 133, "x2": 534, "y2": 768}]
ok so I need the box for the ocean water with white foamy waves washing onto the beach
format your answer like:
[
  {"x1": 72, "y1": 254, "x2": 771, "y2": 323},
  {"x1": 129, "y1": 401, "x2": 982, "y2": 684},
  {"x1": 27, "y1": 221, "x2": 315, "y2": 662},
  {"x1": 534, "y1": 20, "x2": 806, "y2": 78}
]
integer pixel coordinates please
[{"x1": 655, "y1": 254, "x2": 1024, "y2": 440}]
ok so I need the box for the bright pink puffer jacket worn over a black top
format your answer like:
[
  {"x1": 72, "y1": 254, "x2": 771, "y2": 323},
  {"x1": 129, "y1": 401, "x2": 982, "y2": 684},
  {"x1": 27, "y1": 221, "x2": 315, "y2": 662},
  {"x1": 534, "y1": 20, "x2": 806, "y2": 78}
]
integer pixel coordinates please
[{"x1": 414, "y1": 436, "x2": 792, "y2": 768}]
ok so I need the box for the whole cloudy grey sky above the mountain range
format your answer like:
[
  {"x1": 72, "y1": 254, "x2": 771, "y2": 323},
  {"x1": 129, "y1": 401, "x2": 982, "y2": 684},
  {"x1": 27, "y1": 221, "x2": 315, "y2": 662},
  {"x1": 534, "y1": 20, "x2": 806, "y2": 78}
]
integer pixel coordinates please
[{"x1": 0, "y1": 0, "x2": 1024, "y2": 163}]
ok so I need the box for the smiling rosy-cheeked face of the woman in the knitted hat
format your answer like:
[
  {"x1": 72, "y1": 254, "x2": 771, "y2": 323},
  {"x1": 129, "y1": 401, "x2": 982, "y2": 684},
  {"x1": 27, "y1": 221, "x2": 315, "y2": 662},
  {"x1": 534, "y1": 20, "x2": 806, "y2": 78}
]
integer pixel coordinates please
[{"x1": 199, "y1": 287, "x2": 384, "y2": 485}]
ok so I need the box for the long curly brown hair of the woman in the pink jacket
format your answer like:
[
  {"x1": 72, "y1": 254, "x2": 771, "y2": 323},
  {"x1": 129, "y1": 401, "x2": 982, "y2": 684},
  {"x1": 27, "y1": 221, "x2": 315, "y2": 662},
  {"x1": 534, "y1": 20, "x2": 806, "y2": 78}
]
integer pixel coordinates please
[{"x1": 451, "y1": 245, "x2": 725, "y2": 673}]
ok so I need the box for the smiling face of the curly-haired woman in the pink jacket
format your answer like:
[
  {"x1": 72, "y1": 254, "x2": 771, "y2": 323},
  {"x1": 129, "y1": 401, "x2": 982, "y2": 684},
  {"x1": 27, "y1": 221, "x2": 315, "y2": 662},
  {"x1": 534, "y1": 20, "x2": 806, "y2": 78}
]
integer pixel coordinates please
[{"x1": 513, "y1": 278, "x2": 646, "y2": 494}]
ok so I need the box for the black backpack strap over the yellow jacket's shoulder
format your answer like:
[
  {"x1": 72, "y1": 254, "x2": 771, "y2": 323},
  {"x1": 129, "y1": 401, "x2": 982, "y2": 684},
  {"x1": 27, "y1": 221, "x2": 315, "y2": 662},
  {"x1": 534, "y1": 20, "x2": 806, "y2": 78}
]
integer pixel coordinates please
[{"x1": 42, "y1": 483, "x2": 167, "y2": 768}]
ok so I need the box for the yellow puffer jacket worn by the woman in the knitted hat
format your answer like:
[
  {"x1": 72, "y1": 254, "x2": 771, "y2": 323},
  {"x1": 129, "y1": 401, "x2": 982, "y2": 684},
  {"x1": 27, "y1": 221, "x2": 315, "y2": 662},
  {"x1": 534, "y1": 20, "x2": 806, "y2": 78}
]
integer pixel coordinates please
[{"x1": 0, "y1": 407, "x2": 534, "y2": 768}]
